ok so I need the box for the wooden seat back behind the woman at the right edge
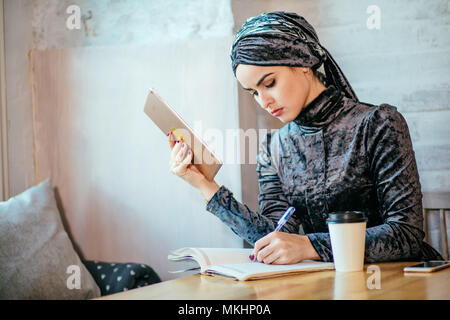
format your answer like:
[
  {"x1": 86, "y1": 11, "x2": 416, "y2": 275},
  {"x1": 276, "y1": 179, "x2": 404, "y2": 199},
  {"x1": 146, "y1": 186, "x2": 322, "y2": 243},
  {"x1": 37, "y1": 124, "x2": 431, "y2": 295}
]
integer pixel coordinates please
[{"x1": 422, "y1": 192, "x2": 450, "y2": 260}]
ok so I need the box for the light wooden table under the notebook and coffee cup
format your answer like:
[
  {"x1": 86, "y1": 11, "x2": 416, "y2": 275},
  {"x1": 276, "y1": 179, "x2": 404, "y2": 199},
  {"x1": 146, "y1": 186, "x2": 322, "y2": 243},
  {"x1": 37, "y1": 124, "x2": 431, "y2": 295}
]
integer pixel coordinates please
[{"x1": 96, "y1": 262, "x2": 450, "y2": 300}]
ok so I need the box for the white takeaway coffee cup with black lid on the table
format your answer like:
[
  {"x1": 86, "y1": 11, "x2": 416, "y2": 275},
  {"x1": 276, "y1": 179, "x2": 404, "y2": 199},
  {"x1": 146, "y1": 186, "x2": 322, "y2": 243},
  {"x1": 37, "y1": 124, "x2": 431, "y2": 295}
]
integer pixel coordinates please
[{"x1": 327, "y1": 211, "x2": 367, "y2": 272}]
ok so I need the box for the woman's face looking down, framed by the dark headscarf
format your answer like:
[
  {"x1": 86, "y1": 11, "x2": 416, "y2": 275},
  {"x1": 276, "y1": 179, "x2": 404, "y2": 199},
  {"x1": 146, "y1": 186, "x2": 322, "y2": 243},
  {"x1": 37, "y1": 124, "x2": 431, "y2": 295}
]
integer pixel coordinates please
[{"x1": 236, "y1": 64, "x2": 312, "y2": 122}]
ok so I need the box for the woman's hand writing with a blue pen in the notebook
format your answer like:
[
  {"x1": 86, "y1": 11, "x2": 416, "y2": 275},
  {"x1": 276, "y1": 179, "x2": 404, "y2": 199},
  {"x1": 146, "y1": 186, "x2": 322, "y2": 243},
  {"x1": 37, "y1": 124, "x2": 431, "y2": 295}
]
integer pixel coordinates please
[{"x1": 250, "y1": 232, "x2": 320, "y2": 264}]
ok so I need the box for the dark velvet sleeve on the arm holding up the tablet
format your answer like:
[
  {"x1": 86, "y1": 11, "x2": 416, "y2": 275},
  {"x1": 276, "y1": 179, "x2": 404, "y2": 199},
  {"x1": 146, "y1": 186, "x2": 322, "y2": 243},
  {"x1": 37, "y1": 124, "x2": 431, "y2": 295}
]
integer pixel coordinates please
[{"x1": 206, "y1": 133, "x2": 299, "y2": 244}]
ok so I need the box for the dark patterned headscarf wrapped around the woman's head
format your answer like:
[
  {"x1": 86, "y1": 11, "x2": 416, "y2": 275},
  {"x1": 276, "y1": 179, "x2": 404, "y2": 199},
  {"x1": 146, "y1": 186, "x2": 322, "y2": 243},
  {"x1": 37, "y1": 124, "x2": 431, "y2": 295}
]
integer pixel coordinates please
[{"x1": 231, "y1": 11, "x2": 358, "y2": 100}]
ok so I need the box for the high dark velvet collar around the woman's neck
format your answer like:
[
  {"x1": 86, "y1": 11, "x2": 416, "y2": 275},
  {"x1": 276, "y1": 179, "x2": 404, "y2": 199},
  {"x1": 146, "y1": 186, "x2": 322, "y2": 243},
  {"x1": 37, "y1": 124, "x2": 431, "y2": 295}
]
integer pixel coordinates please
[{"x1": 294, "y1": 85, "x2": 344, "y2": 128}]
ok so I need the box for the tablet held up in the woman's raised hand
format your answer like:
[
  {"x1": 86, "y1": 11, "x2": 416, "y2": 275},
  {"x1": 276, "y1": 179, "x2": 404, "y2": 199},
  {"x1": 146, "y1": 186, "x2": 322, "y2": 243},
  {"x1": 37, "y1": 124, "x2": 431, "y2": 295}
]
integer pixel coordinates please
[{"x1": 144, "y1": 89, "x2": 222, "y2": 181}]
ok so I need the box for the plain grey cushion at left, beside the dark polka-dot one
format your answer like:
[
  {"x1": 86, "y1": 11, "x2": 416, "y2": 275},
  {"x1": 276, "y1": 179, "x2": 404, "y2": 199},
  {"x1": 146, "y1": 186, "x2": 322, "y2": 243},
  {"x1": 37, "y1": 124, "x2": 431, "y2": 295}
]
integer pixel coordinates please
[{"x1": 0, "y1": 179, "x2": 100, "y2": 299}]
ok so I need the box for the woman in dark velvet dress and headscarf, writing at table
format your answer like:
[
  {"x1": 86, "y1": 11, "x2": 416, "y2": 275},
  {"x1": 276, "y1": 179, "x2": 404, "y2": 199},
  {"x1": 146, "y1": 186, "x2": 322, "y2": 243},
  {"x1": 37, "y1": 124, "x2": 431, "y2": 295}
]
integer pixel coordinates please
[{"x1": 169, "y1": 12, "x2": 442, "y2": 264}]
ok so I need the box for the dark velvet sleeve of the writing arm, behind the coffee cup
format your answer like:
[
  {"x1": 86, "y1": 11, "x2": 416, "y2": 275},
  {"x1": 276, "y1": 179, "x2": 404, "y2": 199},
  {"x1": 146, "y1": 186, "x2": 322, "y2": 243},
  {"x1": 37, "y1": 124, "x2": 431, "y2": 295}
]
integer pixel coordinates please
[{"x1": 308, "y1": 105, "x2": 440, "y2": 262}]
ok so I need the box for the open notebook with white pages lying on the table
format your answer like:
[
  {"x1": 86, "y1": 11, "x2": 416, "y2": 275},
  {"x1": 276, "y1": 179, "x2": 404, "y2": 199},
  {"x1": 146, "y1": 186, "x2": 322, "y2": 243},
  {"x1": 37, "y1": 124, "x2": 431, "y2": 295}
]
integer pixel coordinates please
[{"x1": 168, "y1": 248, "x2": 334, "y2": 280}]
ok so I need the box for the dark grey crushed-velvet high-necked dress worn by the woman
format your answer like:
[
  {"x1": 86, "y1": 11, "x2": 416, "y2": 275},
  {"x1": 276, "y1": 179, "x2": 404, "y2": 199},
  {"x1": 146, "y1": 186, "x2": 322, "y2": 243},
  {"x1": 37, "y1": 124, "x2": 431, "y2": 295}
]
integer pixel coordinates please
[{"x1": 207, "y1": 86, "x2": 442, "y2": 263}]
